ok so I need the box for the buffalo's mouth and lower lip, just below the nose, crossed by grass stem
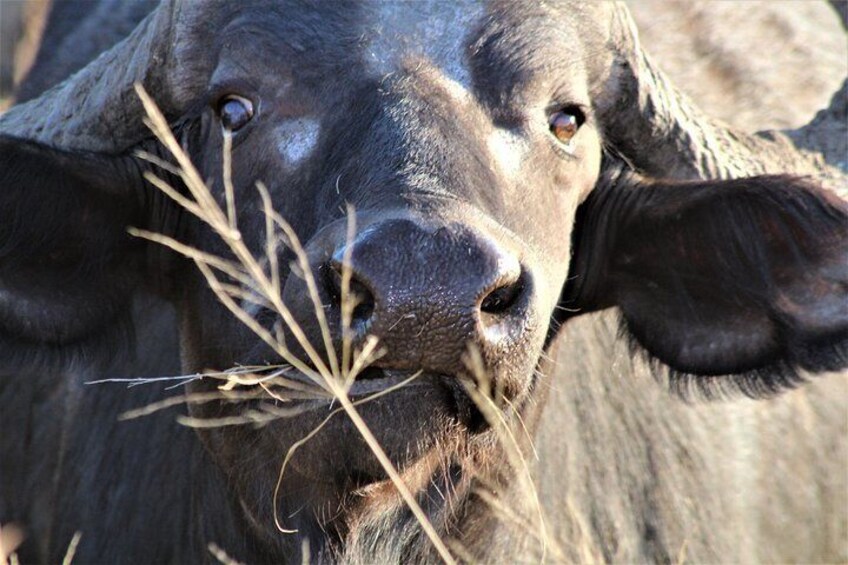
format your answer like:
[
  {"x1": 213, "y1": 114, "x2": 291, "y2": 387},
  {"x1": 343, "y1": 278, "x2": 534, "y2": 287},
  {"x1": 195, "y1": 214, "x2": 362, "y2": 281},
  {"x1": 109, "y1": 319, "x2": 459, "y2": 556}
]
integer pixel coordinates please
[{"x1": 235, "y1": 366, "x2": 487, "y2": 484}]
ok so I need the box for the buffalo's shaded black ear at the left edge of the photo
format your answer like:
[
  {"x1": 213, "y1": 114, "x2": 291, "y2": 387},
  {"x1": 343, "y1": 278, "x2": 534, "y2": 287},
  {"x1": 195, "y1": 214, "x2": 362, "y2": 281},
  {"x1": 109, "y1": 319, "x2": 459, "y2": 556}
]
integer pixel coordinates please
[{"x1": 0, "y1": 136, "x2": 142, "y2": 352}]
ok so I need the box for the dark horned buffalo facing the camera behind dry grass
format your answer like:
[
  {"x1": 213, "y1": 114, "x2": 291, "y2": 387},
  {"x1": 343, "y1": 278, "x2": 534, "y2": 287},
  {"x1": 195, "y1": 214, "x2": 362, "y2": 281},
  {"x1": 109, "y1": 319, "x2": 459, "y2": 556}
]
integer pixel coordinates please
[{"x1": 0, "y1": 0, "x2": 848, "y2": 563}]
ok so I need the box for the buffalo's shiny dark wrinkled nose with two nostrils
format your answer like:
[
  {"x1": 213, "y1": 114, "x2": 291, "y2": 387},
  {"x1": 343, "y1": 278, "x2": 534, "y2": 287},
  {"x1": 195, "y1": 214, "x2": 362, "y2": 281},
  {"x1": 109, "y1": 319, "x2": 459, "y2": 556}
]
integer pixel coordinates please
[{"x1": 321, "y1": 219, "x2": 528, "y2": 372}]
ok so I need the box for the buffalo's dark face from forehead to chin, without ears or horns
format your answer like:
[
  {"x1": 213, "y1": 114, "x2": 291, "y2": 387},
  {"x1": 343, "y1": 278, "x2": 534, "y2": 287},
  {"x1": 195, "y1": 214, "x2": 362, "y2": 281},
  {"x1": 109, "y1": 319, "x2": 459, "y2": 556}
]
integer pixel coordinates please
[{"x1": 172, "y1": 4, "x2": 601, "y2": 523}]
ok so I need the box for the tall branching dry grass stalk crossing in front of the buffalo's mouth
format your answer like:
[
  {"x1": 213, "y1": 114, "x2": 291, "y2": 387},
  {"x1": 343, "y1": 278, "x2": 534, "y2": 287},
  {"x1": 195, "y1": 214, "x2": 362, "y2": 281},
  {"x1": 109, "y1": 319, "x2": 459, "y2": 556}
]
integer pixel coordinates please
[{"x1": 131, "y1": 85, "x2": 455, "y2": 563}]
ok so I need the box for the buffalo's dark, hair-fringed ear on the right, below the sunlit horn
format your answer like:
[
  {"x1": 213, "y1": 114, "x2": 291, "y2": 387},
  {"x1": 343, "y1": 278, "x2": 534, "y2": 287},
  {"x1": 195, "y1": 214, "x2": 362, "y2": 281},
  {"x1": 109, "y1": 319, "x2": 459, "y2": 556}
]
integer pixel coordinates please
[{"x1": 562, "y1": 175, "x2": 848, "y2": 396}]
